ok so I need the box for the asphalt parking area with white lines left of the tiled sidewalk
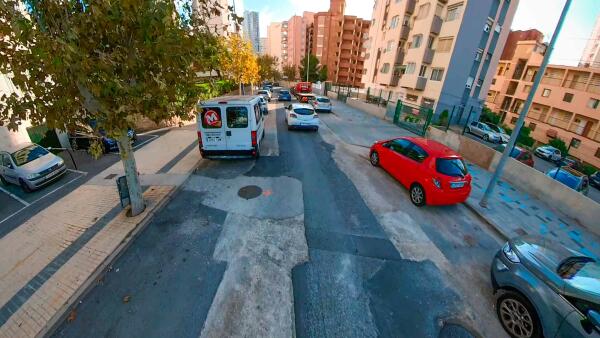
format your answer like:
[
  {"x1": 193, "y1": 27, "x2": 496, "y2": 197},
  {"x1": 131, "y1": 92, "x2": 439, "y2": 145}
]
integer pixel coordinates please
[{"x1": 0, "y1": 130, "x2": 166, "y2": 237}]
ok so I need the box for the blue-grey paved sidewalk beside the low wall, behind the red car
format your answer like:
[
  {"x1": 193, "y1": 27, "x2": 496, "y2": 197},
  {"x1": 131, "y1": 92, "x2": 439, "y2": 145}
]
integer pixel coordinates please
[{"x1": 320, "y1": 100, "x2": 600, "y2": 258}]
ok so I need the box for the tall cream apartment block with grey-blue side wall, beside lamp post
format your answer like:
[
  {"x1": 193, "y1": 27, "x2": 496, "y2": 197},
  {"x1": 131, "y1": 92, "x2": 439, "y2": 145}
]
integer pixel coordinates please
[{"x1": 363, "y1": 0, "x2": 518, "y2": 122}]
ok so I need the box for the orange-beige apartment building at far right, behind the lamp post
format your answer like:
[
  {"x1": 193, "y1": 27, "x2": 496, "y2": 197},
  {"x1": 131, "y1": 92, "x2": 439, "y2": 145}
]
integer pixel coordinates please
[{"x1": 486, "y1": 33, "x2": 600, "y2": 167}]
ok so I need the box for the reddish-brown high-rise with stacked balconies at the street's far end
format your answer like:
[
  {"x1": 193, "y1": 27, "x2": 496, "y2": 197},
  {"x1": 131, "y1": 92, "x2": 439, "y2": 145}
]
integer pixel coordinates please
[{"x1": 307, "y1": 0, "x2": 370, "y2": 87}]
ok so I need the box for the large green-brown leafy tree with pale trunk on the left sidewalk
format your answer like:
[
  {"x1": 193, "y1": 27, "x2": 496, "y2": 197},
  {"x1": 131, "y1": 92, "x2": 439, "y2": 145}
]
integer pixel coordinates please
[{"x1": 0, "y1": 0, "x2": 229, "y2": 216}]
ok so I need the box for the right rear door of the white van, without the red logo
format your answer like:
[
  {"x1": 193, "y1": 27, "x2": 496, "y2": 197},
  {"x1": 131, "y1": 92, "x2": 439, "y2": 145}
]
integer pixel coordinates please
[{"x1": 225, "y1": 106, "x2": 254, "y2": 150}]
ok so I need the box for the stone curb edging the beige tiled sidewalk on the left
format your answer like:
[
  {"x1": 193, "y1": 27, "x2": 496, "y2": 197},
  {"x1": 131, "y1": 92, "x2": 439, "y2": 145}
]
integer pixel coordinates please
[{"x1": 44, "y1": 185, "x2": 181, "y2": 337}]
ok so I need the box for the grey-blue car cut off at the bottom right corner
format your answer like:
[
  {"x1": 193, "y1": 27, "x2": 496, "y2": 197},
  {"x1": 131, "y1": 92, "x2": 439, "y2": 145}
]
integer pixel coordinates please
[{"x1": 491, "y1": 236, "x2": 600, "y2": 338}]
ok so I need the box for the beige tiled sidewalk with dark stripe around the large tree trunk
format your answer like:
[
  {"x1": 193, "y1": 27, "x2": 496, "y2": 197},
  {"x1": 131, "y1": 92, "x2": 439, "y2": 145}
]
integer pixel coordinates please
[{"x1": 0, "y1": 126, "x2": 200, "y2": 337}]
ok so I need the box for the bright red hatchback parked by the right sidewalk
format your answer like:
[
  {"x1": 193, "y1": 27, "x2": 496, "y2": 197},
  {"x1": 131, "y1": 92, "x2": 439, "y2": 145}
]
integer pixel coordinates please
[{"x1": 370, "y1": 137, "x2": 471, "y2": 207}]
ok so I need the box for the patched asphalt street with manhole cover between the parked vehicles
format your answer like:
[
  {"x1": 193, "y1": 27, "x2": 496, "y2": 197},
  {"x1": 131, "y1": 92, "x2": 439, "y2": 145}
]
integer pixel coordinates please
[{"x1": 54, "y1": 103, "x2": 504, "y2": 337}]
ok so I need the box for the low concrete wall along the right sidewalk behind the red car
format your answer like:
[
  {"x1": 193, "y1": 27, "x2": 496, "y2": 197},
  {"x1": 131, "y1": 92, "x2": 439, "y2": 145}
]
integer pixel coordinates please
[{"x1": 427, "y1": 127, "x2": 600, "y2": 235}]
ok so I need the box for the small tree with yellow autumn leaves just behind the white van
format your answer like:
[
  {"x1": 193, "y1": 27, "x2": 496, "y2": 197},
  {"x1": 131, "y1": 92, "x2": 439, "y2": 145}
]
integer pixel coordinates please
[{"x1": 221, "y1": 34, "x2": 259, "y2": 93}]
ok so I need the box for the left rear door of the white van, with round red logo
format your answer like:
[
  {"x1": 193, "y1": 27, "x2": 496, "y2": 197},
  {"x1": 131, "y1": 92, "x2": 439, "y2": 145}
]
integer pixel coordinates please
[{"x1": 198, "y1": 106, "x2": 227, "y2": 150}]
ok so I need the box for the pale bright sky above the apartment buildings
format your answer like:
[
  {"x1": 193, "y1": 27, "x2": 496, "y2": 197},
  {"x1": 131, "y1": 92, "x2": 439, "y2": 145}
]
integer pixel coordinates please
[{"x1": 238, "y1": 0, "x2": 600, "y2": 65}]
